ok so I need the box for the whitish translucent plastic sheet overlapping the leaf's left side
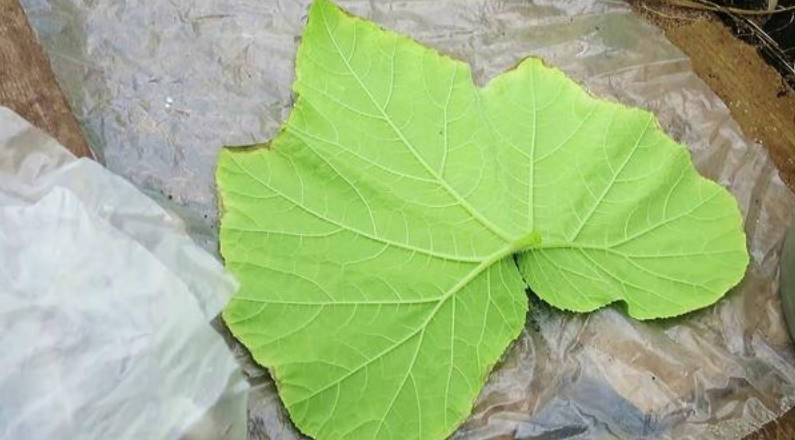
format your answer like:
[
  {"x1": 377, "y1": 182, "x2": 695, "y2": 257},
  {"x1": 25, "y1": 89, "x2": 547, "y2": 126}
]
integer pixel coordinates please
[{"x1": 0, "y1": 107, "x2": 247, "y2": 440}]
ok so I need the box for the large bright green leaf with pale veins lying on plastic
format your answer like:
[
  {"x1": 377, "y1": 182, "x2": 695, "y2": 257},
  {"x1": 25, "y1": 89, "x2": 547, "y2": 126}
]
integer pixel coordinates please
[{"x1": 217, "y1": 0, "x2": 748, "y2": 440}]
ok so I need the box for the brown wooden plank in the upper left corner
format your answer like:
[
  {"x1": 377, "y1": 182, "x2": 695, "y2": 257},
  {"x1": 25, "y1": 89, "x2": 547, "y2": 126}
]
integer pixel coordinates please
[{"x1": 0, "y1": 0, "x2": 93, "y2": 157}]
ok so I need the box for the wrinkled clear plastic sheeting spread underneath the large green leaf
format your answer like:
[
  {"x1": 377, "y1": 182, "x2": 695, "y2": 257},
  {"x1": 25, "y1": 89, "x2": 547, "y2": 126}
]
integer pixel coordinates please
[{"x1": 22, "y1": 0, "x2": 795, "y2": 440}]
